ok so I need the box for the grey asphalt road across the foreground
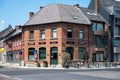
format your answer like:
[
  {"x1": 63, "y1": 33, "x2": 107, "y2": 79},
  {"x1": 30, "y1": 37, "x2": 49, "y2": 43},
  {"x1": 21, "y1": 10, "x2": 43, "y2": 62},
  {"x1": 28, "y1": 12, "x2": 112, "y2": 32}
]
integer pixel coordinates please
[{"x1": 0, "y1": 68, "x2": 120, "y2": 80}]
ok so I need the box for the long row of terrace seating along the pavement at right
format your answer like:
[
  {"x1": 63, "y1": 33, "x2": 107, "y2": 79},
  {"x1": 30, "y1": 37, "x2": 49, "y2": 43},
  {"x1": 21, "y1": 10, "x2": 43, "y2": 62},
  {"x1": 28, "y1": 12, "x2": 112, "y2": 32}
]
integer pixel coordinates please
[{"x1": 67, "y1": 60, "x2": 120, "y2": 68}]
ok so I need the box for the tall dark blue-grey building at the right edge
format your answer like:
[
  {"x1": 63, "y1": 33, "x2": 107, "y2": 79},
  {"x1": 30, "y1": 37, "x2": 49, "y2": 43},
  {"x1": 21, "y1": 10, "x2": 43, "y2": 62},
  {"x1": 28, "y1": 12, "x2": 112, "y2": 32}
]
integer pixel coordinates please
[{"x1": 88, "y1": 0, "x2": 120, "y2": 62}]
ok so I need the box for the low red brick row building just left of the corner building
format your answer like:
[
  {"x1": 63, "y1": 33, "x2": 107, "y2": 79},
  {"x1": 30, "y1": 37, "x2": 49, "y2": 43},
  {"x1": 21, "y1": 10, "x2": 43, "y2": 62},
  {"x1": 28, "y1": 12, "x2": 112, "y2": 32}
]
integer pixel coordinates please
[{"x1": 3, "y1": 26, "x2": 22, "y2": 63}]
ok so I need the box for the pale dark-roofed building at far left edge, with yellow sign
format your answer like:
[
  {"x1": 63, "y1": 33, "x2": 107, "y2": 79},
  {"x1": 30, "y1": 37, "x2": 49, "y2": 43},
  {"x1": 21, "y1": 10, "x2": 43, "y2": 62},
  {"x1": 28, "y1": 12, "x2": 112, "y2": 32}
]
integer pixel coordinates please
[{"x1": 0, "y1": 25, "x2": 13, "y2": 63}]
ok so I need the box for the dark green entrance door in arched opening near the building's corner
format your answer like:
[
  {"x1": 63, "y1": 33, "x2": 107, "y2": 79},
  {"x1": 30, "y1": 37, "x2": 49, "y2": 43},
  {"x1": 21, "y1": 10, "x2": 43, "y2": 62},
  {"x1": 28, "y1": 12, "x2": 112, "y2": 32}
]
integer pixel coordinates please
[{"x1": 51, "y1": 47, "x2": 58, "y2": 65}]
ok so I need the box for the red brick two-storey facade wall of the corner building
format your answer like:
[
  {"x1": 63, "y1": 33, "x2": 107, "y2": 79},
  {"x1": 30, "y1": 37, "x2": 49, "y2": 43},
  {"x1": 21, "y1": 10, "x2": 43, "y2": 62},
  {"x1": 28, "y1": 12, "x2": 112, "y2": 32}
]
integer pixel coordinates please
[{"x1": 23, "y1": 23, "x2": 109, "y2": 64}]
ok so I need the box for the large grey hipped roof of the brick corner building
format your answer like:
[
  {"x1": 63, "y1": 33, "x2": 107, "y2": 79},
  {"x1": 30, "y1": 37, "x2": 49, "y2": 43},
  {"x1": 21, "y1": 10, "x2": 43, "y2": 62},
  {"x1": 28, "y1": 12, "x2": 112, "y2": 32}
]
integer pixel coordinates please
[{"x1": 24, "y1": 4, "x2": 91, "y2": 26}]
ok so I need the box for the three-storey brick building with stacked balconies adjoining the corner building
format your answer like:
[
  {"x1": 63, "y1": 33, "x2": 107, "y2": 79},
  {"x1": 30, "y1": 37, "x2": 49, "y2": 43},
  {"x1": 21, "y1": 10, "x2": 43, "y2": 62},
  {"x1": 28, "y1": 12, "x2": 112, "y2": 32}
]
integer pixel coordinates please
[{"x1": 80, "y1": 7, "x2": 110, "y2": 62}]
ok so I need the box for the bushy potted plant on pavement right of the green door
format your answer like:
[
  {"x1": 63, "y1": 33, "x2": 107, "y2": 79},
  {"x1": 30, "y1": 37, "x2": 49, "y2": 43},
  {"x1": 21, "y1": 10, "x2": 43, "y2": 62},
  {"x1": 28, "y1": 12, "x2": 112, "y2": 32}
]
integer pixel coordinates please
[{"x1": 62, "y1": 52, "x2": 70, "y2": 68}]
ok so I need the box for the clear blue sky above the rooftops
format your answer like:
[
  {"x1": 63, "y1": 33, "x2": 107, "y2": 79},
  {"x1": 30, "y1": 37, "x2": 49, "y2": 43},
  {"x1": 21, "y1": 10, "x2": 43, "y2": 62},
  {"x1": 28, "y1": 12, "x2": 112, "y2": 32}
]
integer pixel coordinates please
[{"x1": 0, "y1": 0, "x2": 90, "y2": 31}]
